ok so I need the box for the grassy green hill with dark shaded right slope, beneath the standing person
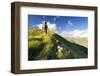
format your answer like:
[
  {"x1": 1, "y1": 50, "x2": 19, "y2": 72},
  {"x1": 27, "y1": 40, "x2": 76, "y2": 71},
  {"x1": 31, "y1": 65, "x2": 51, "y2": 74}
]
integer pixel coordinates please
[{"x1": 28, "y1": 28, "x2": 88, "y2": 60}]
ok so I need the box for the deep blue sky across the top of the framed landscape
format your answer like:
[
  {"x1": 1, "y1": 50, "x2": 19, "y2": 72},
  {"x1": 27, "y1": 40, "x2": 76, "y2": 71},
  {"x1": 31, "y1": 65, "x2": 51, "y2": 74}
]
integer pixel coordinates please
[{"x1": 28, "y1": 15, "x2": 88, "y2": 35}]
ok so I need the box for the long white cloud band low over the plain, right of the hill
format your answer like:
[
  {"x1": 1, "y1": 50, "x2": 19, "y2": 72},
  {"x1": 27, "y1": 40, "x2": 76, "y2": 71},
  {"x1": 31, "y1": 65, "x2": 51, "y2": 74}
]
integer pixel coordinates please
[{"x1": 59, "y1": 30, "x2": 88, "y2": 38}]
